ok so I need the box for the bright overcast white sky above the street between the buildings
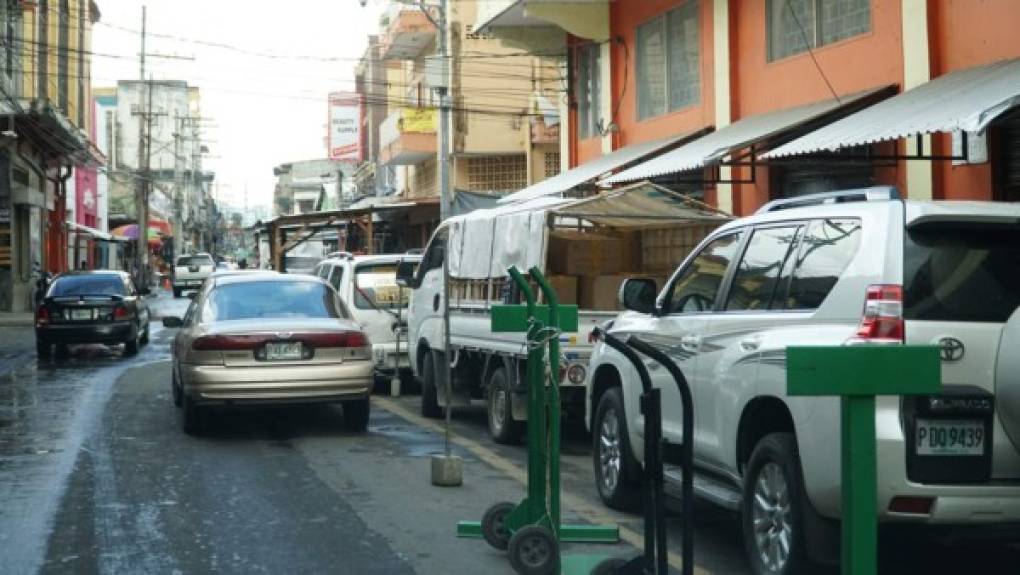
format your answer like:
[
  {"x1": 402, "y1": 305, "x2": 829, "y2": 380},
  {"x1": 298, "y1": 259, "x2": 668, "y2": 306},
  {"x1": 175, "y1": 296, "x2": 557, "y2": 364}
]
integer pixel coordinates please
[{"x1": 92, "y1": 0, "x2": 388, "y2": 216}]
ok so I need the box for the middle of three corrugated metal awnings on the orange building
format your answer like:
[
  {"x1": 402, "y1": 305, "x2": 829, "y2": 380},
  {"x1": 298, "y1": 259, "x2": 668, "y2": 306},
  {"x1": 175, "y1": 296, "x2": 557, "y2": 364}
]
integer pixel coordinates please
[{"x1": 602, "y1": 88, "x2": 888, "y2": 184}]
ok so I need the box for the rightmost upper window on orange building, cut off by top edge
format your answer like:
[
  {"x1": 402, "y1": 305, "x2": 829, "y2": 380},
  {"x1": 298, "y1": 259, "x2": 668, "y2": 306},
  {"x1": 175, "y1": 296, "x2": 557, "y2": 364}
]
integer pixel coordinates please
[{"x1": 768, "y1": 0, "x2": 871, "y2": 60}]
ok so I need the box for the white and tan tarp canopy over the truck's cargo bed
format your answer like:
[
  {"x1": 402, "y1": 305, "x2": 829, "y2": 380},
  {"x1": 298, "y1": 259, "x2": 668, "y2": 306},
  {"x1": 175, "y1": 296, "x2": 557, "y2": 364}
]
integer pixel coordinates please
[{"x1": 449, "y1": 181, "x2": 730, "y2": 279}]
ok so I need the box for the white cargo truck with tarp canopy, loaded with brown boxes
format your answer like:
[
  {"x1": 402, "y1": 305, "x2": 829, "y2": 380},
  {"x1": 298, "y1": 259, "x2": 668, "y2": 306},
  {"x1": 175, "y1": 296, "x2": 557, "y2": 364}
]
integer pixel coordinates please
[{"x1": 398, "y1": 184, "x2": 728, "y2": 442}]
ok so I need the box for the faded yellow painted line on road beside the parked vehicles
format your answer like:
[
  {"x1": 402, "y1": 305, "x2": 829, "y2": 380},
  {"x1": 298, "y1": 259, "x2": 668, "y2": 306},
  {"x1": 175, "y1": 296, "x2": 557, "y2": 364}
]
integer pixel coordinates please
[{"x1": 372, "y1": 396, "x2": 711, "y2": 575}]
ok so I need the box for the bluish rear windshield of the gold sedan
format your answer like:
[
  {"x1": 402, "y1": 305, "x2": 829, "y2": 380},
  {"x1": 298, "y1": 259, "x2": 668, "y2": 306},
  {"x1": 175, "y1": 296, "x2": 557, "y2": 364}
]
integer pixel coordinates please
[{"x1": 202, "y1": 281, "x2": 350, "y2": 322}]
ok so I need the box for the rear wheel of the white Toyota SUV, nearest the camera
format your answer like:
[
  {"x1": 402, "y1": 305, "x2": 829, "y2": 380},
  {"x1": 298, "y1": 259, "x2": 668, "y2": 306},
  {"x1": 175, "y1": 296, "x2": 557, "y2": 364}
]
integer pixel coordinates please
[{"x1": 741, "y1": 433, "x2": 808, "y2": 575}]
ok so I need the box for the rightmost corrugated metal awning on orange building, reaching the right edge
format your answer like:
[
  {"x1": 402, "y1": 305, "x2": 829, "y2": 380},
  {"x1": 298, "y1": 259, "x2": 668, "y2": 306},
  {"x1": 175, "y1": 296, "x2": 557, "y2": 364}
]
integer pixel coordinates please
[{"x1": 762, "y1": 58, "x2": 1020, "y2": 158}]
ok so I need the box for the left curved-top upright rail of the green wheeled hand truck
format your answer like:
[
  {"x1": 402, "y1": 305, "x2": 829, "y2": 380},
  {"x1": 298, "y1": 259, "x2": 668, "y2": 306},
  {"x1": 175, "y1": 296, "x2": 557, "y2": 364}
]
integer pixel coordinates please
[{"x1": 508, "y1": 266, "x2": 547, "y2": 529}]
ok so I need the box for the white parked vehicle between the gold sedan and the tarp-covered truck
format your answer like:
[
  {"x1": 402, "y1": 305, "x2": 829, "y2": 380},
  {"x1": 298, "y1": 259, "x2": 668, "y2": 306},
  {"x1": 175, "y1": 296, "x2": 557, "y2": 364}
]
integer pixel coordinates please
[{"x1": 312, "y1": 252, "x2": 421, "y2": 388}]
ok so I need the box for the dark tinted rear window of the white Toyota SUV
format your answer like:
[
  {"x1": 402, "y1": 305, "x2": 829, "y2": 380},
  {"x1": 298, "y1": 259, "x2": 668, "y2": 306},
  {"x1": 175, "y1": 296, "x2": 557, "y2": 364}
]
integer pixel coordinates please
[{"x1": 904, "y1": 223, "x2": 1020, "y2": 322}]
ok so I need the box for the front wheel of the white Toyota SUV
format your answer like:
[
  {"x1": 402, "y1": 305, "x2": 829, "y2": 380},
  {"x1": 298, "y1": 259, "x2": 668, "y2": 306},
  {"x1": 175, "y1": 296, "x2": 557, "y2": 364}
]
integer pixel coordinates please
[{"x1": 592, "y1": 387, "x2": 641, "y2": 510}]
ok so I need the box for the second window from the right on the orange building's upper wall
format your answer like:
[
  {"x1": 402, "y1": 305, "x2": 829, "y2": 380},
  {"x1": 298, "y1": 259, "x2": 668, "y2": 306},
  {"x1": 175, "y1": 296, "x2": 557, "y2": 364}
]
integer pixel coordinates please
[{"x1": 638, "y1": 0, "x2": 701, "y2": 119}]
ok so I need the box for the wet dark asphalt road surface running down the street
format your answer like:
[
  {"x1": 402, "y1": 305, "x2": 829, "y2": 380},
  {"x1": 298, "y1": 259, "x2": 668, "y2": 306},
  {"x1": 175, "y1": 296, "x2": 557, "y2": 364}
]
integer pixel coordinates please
[{"x1": 0, "y1": 293, "x2": 1020, "y2": 575}]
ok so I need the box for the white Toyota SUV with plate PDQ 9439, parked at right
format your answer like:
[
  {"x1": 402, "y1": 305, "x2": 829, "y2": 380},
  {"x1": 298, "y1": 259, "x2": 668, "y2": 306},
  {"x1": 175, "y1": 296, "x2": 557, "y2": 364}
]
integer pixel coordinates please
[{"x1": 587, "y1": 188, "x2": 1020, "y2": 574}]
